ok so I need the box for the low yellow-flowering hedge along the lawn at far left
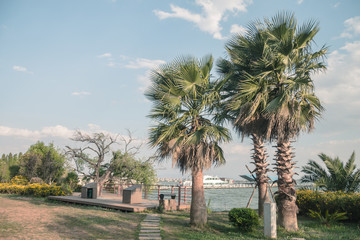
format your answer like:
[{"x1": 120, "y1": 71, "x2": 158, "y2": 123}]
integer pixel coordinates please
[{"x1": 0, "y1": 183, "x2": 68, "y2": 197}]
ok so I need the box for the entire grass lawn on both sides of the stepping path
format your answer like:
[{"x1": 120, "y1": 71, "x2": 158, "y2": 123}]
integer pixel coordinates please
[{"x1": 0, "y1": 194, "x2": 360, "y2": 240}]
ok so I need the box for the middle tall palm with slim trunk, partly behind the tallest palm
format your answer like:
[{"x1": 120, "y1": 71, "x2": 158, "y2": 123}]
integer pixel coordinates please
[{"x1": 218, "y1": 25, "x2": 270, "y2": 217}]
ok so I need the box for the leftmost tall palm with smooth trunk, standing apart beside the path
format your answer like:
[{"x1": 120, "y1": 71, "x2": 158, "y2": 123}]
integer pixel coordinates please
[{"x1": 146, "y1": 56, "x2": 230, "y2": 227}]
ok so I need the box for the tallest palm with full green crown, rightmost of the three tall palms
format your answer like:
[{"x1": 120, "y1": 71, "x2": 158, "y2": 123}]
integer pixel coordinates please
[{"x1": 219, "y1": 13, "x2": 327, "y2": 231}]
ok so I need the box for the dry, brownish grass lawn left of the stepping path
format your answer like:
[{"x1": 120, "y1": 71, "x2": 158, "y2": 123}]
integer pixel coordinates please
[{"x1": 0, "y1": 194, "x2": 145, "y2": 240}]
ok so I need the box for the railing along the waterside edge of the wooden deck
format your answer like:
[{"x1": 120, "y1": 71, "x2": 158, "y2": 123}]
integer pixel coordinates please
[{"x1": 100, "y1": 183, "x2": 191, "y2": 206}]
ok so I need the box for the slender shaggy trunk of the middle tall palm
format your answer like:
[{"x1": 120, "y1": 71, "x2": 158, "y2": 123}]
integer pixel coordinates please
[{"x1": 252, "y1": 134, "x2": 270, "y2": 217}]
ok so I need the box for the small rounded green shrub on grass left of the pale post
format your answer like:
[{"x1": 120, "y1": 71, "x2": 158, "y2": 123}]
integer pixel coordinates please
[{"x1": 229, "y1": 208, "x2": 259, "y2": 232}]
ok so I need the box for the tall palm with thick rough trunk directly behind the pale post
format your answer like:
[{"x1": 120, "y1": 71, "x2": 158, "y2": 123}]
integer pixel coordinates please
[{"x1": 262, "y1": 13, "x2": 327, "y2": 231}]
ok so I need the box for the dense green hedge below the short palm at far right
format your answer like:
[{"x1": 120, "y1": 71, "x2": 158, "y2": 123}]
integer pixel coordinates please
[{"x1": 296, "y1": 190, "x2": 360, "y2": 221}]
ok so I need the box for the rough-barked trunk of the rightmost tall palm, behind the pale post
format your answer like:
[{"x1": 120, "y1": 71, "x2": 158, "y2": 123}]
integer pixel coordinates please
[{"x1": 276, "y1": 140, "x2": 298, "y2": 232}]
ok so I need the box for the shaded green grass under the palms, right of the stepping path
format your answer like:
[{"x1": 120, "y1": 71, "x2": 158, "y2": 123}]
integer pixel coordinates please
[{"x1": 162, "y1": 212, "x2": 360, "y2": 240}]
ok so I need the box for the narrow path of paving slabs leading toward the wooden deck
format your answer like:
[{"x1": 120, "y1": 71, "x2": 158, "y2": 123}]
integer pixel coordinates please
[{"x1": 139, "y1": 214, "x2": 161, "y2": 240}]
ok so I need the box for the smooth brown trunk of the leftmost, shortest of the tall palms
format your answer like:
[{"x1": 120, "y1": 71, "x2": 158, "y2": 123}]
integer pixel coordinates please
[{"x1": 190, "y1": 169, "x2": 207, "y2": 228}]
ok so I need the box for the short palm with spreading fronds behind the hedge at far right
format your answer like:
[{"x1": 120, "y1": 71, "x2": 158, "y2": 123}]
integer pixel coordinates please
[{"x1": 301, "y1": 152, "x2": 360, "y2": 192}]
